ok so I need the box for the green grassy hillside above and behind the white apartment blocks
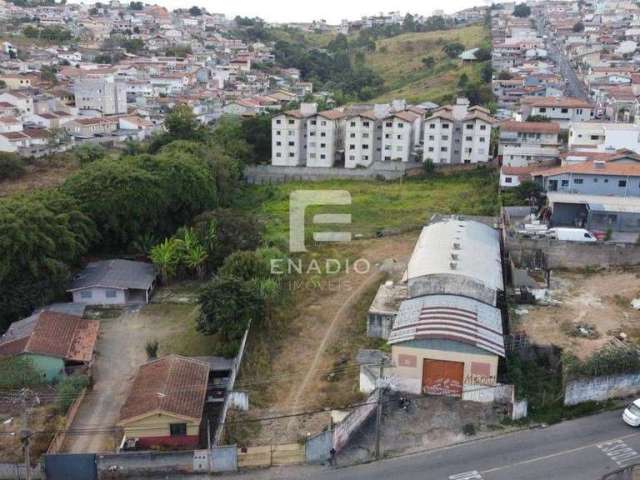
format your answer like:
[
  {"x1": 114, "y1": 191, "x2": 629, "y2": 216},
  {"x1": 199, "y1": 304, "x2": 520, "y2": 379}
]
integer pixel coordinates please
[{"x1": 366, "y1": 25, "x2": 489, "y2": 103}]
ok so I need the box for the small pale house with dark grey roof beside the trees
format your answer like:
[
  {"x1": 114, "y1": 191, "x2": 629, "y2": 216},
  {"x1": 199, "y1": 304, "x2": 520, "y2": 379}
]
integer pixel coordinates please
[{"x1": 67, "y1": 259, "x2": 157, "y2": 305}]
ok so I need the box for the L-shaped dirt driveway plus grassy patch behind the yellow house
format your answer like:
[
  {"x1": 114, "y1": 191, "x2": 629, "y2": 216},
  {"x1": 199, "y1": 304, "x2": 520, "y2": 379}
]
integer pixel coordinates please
[{"x1": 64, "y1": 304, "x2": 202, "y2": 453}]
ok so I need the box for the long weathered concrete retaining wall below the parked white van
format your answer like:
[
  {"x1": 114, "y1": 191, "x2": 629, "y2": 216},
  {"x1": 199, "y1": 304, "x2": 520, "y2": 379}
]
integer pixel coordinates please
[{"x1": 506, "y1": 238, "x2": 640, "y2": 269}]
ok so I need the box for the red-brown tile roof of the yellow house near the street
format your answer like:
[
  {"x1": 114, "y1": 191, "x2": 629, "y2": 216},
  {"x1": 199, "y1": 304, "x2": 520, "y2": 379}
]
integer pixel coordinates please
[{"x1": 120, "y1": 355, "x2": 209, "y2": 424}]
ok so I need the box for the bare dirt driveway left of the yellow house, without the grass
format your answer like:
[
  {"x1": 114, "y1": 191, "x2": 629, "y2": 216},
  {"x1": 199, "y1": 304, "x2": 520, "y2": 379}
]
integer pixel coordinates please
[{"x1": 63, "y1": 308, "x2": 155, "y2": 453}]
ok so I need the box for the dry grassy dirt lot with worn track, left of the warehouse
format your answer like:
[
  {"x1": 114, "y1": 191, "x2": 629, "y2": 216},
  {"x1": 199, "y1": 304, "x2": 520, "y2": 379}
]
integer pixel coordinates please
[{"x1": 238, "y1": 232, "x2": 418, "y2": 445}]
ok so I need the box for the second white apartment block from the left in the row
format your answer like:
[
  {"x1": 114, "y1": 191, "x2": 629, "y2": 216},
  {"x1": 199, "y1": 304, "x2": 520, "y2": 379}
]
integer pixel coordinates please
[{"x1": 306, "y1": 109, "x2": 345, "y2": 167}]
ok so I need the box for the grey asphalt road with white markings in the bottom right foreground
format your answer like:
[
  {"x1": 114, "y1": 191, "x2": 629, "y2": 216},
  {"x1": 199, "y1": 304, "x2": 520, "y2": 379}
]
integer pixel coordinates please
[{"x1": 216, "y1": 410, "x2": 640, "y2": 480}]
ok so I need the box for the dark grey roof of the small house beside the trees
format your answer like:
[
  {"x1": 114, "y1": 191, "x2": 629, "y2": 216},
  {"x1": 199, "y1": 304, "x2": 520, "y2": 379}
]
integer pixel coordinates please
[{"x1": 68, "y1": 259, "x2": 156, "y2": 292}]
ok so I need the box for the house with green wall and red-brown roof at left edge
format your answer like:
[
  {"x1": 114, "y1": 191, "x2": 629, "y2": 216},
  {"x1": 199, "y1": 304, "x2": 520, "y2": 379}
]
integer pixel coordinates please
[{"x1": 0, "y1": 311, "x2": 100, "y2": 382}]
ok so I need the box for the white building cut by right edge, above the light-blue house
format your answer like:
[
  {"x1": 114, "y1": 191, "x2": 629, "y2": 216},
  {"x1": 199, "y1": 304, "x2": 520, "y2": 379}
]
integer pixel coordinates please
[{"x1": 568, "y1": 122, "x2": 640, "y2": 153}]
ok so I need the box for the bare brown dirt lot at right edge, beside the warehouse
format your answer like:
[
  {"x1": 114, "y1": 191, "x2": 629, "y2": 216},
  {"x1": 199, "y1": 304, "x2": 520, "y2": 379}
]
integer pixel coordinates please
[{"x1": 516, "y1": 269, "x2": 640, "y2": 359}]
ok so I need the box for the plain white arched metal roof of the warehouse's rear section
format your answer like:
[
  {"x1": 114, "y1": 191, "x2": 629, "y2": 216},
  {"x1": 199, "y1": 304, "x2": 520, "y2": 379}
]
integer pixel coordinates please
[{"x1": 407, "y1": 218, "x2": 504, "y2": 290}]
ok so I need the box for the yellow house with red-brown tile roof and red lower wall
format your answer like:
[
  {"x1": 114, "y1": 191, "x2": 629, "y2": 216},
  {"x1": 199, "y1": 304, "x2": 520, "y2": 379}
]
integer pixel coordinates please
[{"x1": 117, "y1": 355, "x2": 209, "y2": 448}]
